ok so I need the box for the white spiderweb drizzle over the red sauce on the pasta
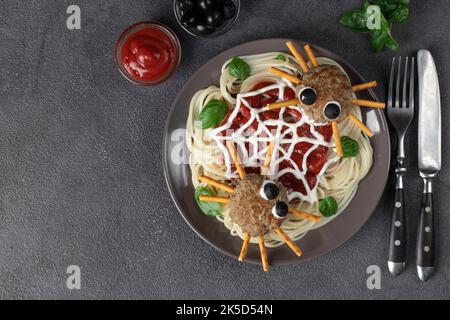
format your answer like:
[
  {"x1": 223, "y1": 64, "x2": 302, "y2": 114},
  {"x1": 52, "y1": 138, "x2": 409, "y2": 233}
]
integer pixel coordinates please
[{"x1": 209, "y1": 79, "x2": 339, "y2": 203}]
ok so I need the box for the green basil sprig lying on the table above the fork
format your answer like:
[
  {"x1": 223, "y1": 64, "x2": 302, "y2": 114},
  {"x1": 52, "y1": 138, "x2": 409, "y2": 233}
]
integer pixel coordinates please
[{"x1": 339, "y1": 0, "x2": 409, "y2": 52}]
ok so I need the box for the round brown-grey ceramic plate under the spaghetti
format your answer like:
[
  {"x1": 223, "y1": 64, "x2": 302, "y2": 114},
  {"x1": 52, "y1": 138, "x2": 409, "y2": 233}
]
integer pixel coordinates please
[{"x1": 163, "y1": 39, "x2": 390, "y2": 265}]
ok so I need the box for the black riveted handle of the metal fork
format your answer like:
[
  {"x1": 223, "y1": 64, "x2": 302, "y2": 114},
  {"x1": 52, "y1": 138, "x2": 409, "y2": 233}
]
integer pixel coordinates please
[{"x1": 388, "y1": 166, "x2": 406, "y2": 276}]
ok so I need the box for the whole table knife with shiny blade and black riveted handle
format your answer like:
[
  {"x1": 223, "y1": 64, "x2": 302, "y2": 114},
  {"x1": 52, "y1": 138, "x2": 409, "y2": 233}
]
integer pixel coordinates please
[{"x1": 416, "y1": 50, "x2": 441, "y2": 281}]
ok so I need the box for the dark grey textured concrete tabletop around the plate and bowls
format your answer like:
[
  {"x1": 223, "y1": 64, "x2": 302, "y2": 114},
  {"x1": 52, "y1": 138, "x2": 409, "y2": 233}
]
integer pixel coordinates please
[{"x1": 0, "y1": 0, "x2": 450, "y2": 299}]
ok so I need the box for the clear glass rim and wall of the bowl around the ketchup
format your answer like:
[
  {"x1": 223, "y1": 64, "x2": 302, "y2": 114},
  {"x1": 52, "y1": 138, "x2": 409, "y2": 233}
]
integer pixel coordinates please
[{"x1": 114, "y1": 21, "x2": 181, "y2": 86}]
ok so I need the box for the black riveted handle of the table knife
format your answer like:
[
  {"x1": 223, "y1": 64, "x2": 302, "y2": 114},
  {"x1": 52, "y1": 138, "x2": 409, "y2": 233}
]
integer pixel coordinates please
[{"x1": 417, "y1": 178, "x2": 435, "y2": 281}]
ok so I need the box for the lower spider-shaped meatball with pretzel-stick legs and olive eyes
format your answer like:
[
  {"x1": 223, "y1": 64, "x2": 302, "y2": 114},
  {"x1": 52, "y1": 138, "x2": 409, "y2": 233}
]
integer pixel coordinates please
[{"x1": 198, "y1": 141, "x2": 320, "y2": 271}]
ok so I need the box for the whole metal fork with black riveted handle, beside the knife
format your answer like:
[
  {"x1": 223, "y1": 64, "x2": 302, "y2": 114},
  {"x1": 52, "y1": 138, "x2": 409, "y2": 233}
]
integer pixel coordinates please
[{"x1": 387, "y1": 57, "x2": 415, "y2": 276}]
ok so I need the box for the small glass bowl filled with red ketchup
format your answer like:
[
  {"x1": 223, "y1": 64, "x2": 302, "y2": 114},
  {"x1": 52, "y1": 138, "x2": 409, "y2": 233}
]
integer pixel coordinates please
[{"x1": 115, "y1": 21, "x2": 181, "y2": 86}]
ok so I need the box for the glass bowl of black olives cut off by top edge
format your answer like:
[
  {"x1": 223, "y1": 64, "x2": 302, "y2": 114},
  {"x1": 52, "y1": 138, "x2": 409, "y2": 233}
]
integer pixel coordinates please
[{"x1": 173, "y1": 0, "x2": 240, "y2": 38}]
